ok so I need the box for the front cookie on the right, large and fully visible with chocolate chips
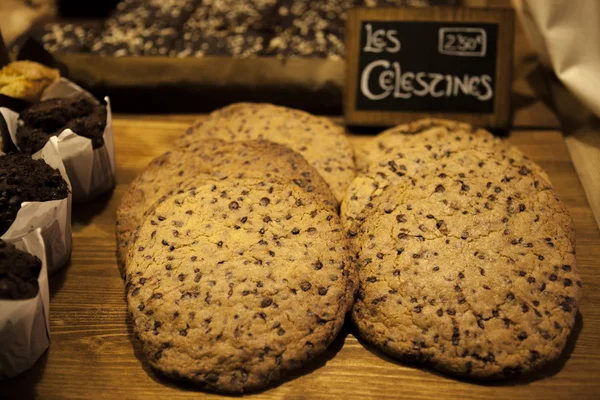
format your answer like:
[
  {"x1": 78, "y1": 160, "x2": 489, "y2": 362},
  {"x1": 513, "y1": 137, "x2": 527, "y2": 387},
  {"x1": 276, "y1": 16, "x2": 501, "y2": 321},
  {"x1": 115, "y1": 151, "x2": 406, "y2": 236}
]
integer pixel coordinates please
[{"x1": 351, "y1": 159, "x2": 581, "y2": 379}]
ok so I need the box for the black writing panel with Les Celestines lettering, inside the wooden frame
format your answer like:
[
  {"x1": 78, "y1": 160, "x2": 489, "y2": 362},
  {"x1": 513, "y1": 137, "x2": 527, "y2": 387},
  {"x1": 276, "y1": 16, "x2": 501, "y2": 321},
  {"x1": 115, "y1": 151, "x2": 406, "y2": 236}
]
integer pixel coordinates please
[{"x1": 356, "y1": 20, "x2": 498, "y2": 114}]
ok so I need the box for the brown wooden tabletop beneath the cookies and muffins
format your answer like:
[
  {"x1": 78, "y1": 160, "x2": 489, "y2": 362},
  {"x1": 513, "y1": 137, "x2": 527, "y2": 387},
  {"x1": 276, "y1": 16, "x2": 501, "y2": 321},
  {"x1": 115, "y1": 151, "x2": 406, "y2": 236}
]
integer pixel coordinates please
[{"x1": 0, "y1": 116, "x2": 600, "y2": 400}]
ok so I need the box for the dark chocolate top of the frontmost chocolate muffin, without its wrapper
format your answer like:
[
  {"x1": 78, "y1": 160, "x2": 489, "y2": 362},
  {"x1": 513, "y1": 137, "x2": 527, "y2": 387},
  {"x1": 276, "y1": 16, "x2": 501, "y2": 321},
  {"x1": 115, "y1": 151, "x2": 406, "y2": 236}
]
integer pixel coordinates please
[{"x1": 0, "y1": 239, "x2": 42, "y2": 300}]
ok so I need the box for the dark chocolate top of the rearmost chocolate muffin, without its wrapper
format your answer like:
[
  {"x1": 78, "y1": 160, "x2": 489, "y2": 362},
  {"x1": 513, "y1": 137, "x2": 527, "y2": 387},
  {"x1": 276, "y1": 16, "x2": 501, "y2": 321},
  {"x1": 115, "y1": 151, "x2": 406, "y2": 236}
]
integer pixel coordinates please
[{"x1": 17, "y1": 95, "x2": 106, "y2": 154}]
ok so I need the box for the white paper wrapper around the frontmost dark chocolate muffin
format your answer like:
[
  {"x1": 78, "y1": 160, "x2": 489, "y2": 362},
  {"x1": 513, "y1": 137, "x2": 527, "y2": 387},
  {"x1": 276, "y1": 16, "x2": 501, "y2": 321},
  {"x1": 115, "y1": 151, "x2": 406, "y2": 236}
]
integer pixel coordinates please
[{"x1": 0, "y1": 229, "x2": 50, "y2": 380}]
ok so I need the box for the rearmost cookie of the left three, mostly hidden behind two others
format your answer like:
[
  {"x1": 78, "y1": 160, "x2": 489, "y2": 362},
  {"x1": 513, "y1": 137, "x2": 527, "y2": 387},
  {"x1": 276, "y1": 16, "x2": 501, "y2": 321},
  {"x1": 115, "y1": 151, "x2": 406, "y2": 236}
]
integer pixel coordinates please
[{"x1": 180, "y1": 103, "x2": 355, "y2": 201}]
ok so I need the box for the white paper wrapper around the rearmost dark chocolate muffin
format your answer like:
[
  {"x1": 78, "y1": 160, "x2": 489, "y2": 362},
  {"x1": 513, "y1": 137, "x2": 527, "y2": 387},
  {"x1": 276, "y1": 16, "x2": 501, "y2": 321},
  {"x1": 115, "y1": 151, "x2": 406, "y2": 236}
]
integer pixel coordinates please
[{"x1": 0, "y1": 78, "x2": 116, "y2": 203}]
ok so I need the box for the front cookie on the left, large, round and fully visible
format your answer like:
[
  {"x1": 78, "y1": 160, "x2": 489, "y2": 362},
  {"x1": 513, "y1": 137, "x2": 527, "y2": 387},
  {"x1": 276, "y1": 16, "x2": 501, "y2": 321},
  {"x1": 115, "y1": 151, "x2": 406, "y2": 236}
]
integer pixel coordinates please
[{"x1": 126, "y1": 179, "x2": 356, "y2": 393}]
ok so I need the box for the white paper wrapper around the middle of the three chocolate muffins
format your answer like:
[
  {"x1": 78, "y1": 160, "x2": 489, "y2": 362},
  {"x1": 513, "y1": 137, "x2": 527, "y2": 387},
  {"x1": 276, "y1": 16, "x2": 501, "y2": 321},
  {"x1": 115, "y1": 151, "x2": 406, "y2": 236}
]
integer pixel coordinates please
[{"x1": 0, "y1": 137, "x2": 71, "y2": 275}]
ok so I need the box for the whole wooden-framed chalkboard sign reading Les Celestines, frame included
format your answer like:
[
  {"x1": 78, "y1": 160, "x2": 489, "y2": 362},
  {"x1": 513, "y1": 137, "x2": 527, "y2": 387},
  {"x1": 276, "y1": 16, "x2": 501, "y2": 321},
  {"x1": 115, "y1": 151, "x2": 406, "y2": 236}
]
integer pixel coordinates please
[{"x1": 344, "y1": 7, "x2": 515, "y2": 129}]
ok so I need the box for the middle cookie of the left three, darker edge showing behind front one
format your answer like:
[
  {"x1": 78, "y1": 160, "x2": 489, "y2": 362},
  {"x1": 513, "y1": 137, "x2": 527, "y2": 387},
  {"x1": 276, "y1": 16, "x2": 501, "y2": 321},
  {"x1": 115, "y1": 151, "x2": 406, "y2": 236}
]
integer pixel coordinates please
[{"x1": 116, "y1": 139, "x2": 337, "y2": 265}]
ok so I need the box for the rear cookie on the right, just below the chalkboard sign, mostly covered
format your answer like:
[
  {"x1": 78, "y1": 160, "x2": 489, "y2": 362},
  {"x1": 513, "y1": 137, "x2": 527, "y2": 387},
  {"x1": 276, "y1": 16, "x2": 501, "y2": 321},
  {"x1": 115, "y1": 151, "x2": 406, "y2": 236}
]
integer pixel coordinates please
[{"x1": 341, "y1": 130, "x2": 560, "y2": 241}]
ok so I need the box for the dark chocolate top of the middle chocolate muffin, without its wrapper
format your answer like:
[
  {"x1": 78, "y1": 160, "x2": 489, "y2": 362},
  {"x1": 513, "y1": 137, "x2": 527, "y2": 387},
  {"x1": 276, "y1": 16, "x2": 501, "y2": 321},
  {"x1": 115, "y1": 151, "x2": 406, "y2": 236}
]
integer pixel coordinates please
[{"x1": 0, "y1": 154, "x2": 69, "y2": 235}]
